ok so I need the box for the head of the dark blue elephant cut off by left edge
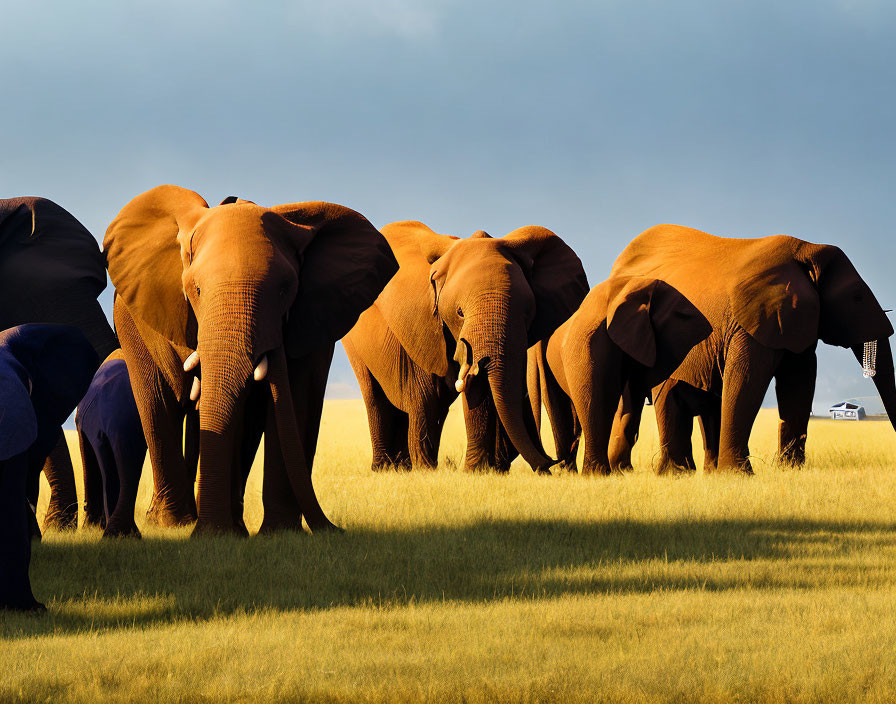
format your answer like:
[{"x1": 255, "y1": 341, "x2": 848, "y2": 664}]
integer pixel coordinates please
[{"x1": 0, "y1": 324, "x2": 99, "y2": 464}]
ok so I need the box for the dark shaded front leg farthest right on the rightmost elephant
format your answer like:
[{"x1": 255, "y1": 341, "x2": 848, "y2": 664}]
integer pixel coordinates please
[{"x1": 775, "y1": 349, "x2": 818, "y2": 467}]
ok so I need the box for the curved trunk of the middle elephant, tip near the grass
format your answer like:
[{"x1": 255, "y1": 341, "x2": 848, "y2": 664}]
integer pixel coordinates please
[{"x1": 461, "y1": 299, "x2": 555, "y2": 472}]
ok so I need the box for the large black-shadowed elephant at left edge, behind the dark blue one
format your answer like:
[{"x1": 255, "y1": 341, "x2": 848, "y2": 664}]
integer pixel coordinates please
[{"x1": 0, "y1": 196, "x2": 118, "y2": 535}]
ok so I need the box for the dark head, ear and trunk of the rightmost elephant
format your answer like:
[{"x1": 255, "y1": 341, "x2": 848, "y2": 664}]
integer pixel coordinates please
[{"x1": 732, "y1": 236, "x2": 896, "y2": 429}]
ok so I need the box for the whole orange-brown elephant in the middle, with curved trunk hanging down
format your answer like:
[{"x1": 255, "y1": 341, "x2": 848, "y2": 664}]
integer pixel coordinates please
[{"x1": 343, "y1": 221, "x2": 588, "y2": 473}]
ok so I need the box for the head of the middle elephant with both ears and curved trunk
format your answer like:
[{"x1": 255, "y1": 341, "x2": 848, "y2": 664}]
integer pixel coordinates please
[{"x1": 378, "y1": 222, "x2": 588, "y2": 470}]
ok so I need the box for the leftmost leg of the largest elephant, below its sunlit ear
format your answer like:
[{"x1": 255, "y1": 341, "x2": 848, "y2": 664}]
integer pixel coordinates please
[{"x1": 114, "y1": 305, "x2": 196, "y2": 526}]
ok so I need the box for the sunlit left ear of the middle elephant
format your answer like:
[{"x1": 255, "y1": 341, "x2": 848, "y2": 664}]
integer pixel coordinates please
[{"x1": 376, "y1": 220, "x2": 458, "y2": 376}]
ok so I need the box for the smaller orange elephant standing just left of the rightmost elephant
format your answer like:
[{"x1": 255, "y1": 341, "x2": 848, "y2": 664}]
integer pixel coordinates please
[{"x1": 527, "y1": 277, "x2": 712, "y2": 475}]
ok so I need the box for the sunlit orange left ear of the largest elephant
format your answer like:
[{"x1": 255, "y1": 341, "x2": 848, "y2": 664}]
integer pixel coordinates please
[{"x1": 103, "y1": 186, "x2": 208, "y2": 347}]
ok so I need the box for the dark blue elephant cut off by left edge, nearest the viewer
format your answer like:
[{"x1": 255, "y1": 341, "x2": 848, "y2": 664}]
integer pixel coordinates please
[{"x1": 0, "y1": 324, "x2": 99, "y2": 611}]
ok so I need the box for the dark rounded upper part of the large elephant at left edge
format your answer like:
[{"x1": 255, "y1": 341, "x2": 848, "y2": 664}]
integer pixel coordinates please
[{"x1": 0, "y1": 196, "x2": 112, "y2": 347}]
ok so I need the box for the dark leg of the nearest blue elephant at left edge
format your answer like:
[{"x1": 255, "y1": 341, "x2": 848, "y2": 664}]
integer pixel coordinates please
[{"x1": 0, "y1": 454, "x2": 45, "y2": 611}]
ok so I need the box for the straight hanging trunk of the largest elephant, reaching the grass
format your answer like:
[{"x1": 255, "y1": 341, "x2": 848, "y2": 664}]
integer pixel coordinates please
[{"x1": 196, "y1": 295, "x2": 255, "y2": 532}]
